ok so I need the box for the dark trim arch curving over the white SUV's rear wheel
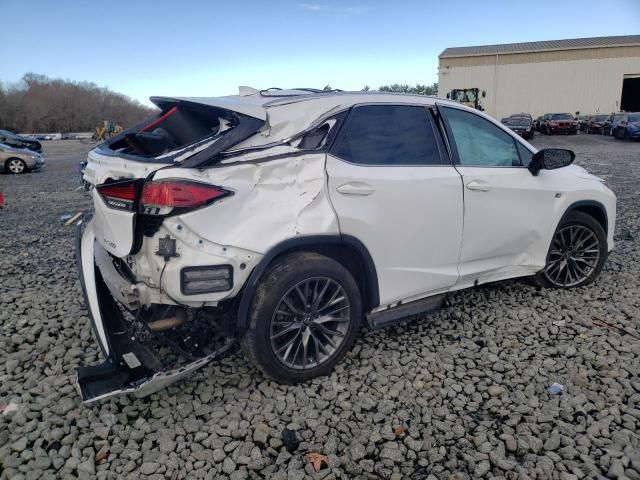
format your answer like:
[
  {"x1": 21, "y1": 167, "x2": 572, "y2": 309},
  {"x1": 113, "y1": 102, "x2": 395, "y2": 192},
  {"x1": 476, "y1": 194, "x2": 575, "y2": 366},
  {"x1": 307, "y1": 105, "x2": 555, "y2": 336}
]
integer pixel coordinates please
[{"x1": 236, "y1": 235, "x2": 380, "y2": 334}]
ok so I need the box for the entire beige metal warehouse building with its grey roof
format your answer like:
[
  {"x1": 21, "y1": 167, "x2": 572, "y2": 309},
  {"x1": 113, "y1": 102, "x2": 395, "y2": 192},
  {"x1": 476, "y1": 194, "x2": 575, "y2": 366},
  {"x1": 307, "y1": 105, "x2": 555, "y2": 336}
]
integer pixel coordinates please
[{"x1": 438, "y1": 35, "x2": 640, "y2": 119}]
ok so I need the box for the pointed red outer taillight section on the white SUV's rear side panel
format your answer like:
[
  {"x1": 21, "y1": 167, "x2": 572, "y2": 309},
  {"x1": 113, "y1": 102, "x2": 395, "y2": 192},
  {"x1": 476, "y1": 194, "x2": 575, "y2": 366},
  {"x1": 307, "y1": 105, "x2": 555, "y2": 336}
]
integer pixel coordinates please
[{"x1": 140, "y1": 180, "x2": 231, "y2": 215}]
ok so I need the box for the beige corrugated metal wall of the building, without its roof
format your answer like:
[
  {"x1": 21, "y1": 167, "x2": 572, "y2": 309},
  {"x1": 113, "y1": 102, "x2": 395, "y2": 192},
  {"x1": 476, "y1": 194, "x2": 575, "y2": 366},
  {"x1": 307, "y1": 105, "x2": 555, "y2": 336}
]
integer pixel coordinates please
[{"x1": 438, "y1": 47, "x2": 640, "y2": 119}]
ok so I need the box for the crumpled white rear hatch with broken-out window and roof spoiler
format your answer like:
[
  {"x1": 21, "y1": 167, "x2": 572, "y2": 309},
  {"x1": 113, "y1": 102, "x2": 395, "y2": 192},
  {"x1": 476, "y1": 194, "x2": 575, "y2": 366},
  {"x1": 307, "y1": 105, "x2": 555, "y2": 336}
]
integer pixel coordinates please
[{"x1": 83, "y1": 97, "x2": 266, "y2": 257}]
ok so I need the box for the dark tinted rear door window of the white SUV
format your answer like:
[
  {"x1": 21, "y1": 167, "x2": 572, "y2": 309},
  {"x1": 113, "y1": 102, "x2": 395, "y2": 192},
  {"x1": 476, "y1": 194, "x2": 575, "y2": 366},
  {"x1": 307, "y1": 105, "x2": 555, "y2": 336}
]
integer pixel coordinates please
[{"x1": 331, "y1": 105, "x2": 442, "y2": 165}]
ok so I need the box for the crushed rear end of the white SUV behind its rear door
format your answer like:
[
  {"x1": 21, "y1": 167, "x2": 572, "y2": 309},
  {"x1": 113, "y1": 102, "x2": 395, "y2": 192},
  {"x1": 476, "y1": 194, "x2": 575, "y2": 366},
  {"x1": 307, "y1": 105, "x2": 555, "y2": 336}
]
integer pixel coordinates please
[{"x1": 76, "y1": 90, "x2": 359, "y2": 401}]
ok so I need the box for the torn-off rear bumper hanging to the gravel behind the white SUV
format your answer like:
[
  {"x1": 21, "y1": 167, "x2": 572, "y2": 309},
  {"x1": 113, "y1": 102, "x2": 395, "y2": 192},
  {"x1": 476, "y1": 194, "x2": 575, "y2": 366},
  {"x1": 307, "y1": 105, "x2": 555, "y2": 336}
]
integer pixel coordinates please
[{"x1": 76, "y1": 221, "x2": 235, "y2": 403}]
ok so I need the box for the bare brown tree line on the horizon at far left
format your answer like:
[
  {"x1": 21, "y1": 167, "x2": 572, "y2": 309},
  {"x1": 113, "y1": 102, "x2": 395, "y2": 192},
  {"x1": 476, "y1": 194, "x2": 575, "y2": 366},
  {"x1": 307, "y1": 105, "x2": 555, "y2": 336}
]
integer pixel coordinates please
[{"x1": 0, "y1": 73, "x2": 154, "y2": 133}]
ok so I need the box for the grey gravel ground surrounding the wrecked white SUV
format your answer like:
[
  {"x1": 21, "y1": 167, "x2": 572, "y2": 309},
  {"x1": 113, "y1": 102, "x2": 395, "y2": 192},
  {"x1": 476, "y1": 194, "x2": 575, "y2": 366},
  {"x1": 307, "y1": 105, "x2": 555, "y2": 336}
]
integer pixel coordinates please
[{"x1": 0, "y1": 135, "x2": 640, "y2": 480}]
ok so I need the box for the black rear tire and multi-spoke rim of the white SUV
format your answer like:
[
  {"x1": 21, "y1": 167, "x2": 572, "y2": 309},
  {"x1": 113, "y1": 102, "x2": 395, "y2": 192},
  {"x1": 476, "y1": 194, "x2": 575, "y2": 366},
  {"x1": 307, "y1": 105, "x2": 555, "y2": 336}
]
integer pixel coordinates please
[{"x1": 240, "y1": 252, "x2": 362, "y2": 384}]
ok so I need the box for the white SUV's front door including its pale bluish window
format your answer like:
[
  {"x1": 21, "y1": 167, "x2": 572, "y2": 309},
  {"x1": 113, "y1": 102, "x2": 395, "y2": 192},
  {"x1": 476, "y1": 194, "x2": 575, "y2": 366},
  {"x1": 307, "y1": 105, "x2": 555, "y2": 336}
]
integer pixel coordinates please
[{"x1": 439, "y1": 106, "x2": 558, "y2": 287}]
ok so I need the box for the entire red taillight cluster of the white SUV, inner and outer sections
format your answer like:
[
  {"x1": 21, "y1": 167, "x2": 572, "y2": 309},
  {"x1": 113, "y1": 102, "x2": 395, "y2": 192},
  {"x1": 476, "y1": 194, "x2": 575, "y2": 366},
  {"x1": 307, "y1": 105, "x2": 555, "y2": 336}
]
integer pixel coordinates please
[{"x1": 96, "y1": 180, "x2": 231, "y2": 215}]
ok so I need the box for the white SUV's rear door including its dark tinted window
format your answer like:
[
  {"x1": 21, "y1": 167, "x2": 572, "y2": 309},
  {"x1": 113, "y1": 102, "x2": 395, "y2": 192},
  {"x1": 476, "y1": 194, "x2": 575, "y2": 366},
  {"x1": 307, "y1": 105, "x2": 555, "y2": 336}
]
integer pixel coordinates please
[{"x1": 327, "y1": 104, "x2": 463, "y2": 306}]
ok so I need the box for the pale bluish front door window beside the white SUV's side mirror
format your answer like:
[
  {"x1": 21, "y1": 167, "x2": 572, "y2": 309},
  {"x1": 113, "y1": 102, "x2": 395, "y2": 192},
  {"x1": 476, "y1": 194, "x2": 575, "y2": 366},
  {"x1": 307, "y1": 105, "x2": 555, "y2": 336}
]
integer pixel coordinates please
[{"x1": 445, "y1": 108, "x2": 522, "y2": 167}]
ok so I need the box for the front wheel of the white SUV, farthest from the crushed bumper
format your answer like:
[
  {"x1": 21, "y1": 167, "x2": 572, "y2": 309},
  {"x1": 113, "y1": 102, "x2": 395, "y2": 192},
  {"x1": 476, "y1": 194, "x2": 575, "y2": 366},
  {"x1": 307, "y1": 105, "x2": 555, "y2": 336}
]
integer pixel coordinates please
[{"x1": 533, "y1": 212, "x2": 608, "y2": 288}]
